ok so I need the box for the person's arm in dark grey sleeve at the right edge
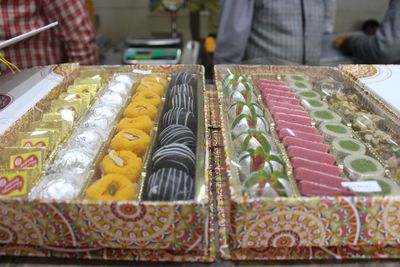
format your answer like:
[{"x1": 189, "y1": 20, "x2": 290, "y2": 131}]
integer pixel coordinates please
[{"x1": 338, "y1": 0, "x2": 400, "y2": 64}]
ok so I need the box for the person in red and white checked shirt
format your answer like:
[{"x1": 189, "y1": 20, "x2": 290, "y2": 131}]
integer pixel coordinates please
[{"x1": 0, "y1": 0, "x2": 99, "y2": 73}]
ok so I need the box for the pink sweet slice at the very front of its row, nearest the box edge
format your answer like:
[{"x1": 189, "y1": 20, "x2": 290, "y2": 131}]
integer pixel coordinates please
[{"x1": 299, "y1": 181, "x2": 353, "y2": 197}]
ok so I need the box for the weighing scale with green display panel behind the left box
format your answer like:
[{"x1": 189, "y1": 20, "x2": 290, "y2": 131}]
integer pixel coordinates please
[{"x1": 122, "y1": 0, "x2": 184, "y2": 64}]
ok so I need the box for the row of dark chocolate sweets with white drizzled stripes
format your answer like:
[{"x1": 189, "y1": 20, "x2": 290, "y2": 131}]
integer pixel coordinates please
[{"x1": 143, "y1": 72, "x2": 198, "y2": 201}]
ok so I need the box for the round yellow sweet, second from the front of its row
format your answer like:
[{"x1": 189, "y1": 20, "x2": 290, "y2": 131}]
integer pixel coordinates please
[{"x1": 102, "y1": 150, "x2": 143, "y2": 182}]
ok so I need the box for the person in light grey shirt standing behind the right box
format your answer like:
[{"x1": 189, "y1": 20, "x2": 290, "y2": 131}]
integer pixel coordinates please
[{"x1": 214, "y1": 0, "x2": 336, "y2": 65}]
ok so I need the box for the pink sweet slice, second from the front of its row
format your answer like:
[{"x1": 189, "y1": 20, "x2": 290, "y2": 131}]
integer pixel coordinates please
[{"x1": 293, "y1": 168, "x2": 349, "y2": 188}]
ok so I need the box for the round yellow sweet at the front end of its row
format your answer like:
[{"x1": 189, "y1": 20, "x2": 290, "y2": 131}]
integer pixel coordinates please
[{"x1": 86, "y1": 174, "x2": 138, "y2": 201}]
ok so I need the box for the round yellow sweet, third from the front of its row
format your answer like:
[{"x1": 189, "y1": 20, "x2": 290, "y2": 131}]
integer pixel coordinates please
[{"x1": 110, "y1": 129, "x2": 150, "y2": 157}]
